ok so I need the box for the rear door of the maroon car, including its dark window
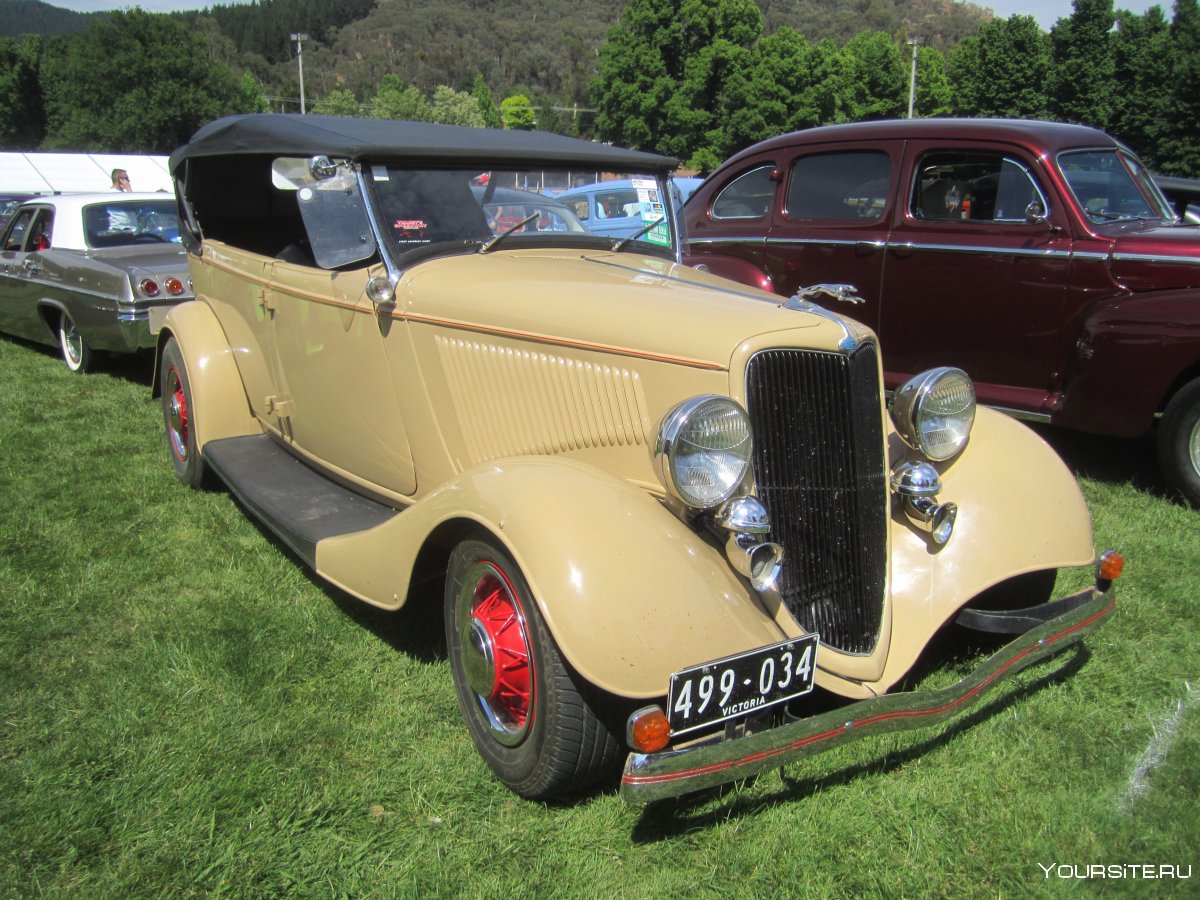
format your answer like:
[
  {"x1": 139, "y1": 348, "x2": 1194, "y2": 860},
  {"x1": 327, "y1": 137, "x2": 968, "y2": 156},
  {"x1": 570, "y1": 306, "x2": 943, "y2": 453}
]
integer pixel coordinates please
[{"x1": 764, "y1": 140, "x2": 904, "y2": 329}]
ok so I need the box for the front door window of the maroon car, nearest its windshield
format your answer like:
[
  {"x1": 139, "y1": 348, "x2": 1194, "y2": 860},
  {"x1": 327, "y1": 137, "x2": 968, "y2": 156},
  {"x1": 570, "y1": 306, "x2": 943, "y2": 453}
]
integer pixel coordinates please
[{"x1": 911, "y1": 150, "x2": 1049, "y2": 223}]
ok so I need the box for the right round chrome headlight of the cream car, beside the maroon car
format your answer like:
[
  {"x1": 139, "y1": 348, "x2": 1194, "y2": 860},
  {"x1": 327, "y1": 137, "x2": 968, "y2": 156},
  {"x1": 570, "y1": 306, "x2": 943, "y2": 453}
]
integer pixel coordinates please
[{"x1": 892, "y1": 366, "x2": 976, "y2": 462}]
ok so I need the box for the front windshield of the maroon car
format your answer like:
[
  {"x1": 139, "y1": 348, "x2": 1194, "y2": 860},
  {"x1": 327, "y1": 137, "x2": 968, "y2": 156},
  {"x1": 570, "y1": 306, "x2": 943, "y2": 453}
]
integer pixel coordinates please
[{"x1": 1058, "y1": 149, "x2": 1175, "y2": 224}]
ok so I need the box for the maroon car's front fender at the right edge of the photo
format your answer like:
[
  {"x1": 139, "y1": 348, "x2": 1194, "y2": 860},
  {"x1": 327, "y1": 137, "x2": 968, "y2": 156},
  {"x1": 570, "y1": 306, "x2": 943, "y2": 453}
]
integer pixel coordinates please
[{"x1": 1051, "y1": 288, "x2": 1200, "y2": 437}]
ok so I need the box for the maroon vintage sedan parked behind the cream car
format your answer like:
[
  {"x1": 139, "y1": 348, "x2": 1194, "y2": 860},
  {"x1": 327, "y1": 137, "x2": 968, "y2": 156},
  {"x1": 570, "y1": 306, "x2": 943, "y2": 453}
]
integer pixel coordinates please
[{"x1": 683, "y1": 119, "x2": 1200, "y2": 505}]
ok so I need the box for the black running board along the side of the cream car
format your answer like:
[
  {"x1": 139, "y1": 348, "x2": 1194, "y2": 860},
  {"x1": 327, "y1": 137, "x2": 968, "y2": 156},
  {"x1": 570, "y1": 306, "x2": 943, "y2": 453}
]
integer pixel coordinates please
[{"x1": 204, "y1": 434, "x2": 400, "y2": 568}]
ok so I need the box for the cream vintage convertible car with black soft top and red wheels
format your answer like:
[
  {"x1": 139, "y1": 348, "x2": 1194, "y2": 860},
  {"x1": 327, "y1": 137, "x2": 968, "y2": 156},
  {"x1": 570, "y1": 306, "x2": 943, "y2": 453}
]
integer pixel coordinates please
[{"x1": 157, "y1": 115, "x2": 1121, "y2": 804}]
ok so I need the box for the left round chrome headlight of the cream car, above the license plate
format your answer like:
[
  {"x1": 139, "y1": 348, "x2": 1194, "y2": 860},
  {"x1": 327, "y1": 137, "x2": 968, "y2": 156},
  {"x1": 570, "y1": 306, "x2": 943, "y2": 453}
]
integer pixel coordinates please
[{"x1": 654, "y1": 395, "x2": 751, "y2": 509}]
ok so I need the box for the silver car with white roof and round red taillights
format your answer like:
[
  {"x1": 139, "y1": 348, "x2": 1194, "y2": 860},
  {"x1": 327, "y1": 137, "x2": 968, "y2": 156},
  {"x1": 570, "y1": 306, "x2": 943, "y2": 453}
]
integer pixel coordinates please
[{"x1": 0, "y1": 192, "x2": 192, "y2": 372}]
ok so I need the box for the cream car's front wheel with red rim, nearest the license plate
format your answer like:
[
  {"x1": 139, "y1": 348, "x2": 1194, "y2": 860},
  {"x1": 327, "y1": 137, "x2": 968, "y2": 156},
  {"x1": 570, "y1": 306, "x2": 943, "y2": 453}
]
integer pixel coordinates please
[{"x1": 445, "y1": 535, "x2": 622, "y2": 800}]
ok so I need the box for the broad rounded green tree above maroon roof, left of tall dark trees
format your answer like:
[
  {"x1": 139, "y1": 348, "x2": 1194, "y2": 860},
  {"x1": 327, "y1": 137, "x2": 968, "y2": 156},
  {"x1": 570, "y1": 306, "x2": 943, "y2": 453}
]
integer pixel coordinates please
[{"x1": 947, "y1": 16, "x2": 1051, "y2": 119}]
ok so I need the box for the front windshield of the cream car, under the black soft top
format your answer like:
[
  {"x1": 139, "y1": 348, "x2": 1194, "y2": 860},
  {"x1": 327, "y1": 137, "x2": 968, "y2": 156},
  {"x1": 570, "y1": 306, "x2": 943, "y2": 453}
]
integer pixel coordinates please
[{"x1": 368, "y1": 166, "x2": 676, "y2": 254}]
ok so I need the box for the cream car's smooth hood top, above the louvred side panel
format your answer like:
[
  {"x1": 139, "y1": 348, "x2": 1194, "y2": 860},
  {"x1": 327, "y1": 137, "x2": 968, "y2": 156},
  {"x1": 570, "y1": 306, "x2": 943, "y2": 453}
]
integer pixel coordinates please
[{"x1": 396, "y1": 250, "x2": 870, "y2": 368}]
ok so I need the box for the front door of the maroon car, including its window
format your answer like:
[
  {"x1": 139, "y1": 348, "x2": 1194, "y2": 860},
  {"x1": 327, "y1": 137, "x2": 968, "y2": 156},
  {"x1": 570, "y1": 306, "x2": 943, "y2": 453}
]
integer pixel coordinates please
[{"x1": 878, "y1": 140, "x2": 1072, "y2": 412}]
